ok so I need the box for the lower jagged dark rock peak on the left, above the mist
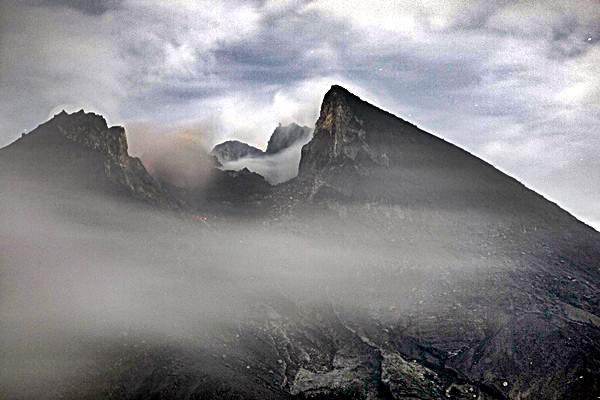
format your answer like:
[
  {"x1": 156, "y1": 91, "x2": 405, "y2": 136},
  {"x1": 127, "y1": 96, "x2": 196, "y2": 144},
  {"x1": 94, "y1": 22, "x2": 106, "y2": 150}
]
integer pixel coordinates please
[{"x1": 0, "y1": 110, "x2": 177, "y2": 207}]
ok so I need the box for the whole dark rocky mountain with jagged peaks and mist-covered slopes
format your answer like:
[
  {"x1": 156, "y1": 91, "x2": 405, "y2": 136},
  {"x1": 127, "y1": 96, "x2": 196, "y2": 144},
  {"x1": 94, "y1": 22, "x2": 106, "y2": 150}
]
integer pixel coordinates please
[{"x1": 0, "y1": 86, "x2": 600, "y2": 400}]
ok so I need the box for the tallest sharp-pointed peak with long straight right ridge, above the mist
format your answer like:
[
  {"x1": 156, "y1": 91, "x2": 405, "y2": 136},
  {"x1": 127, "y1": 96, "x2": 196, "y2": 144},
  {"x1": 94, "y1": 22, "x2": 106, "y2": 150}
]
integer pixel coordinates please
[{"x1": 299, "y1": 86, "x2": 566, "y2": 218}]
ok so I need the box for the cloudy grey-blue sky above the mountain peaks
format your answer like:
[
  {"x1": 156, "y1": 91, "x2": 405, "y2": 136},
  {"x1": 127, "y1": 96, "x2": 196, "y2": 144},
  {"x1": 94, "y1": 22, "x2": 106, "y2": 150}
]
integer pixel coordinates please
[{"x1": 0, "y1": 0, "x2": 600, "y2": 229}]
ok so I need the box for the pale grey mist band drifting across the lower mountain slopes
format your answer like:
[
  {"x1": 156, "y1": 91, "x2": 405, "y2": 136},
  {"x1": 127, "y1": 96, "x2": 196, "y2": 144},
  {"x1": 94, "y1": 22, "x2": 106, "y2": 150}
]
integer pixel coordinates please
[{"x1": 0, "y1": 172, "x2": 501, "y2": 398}]
